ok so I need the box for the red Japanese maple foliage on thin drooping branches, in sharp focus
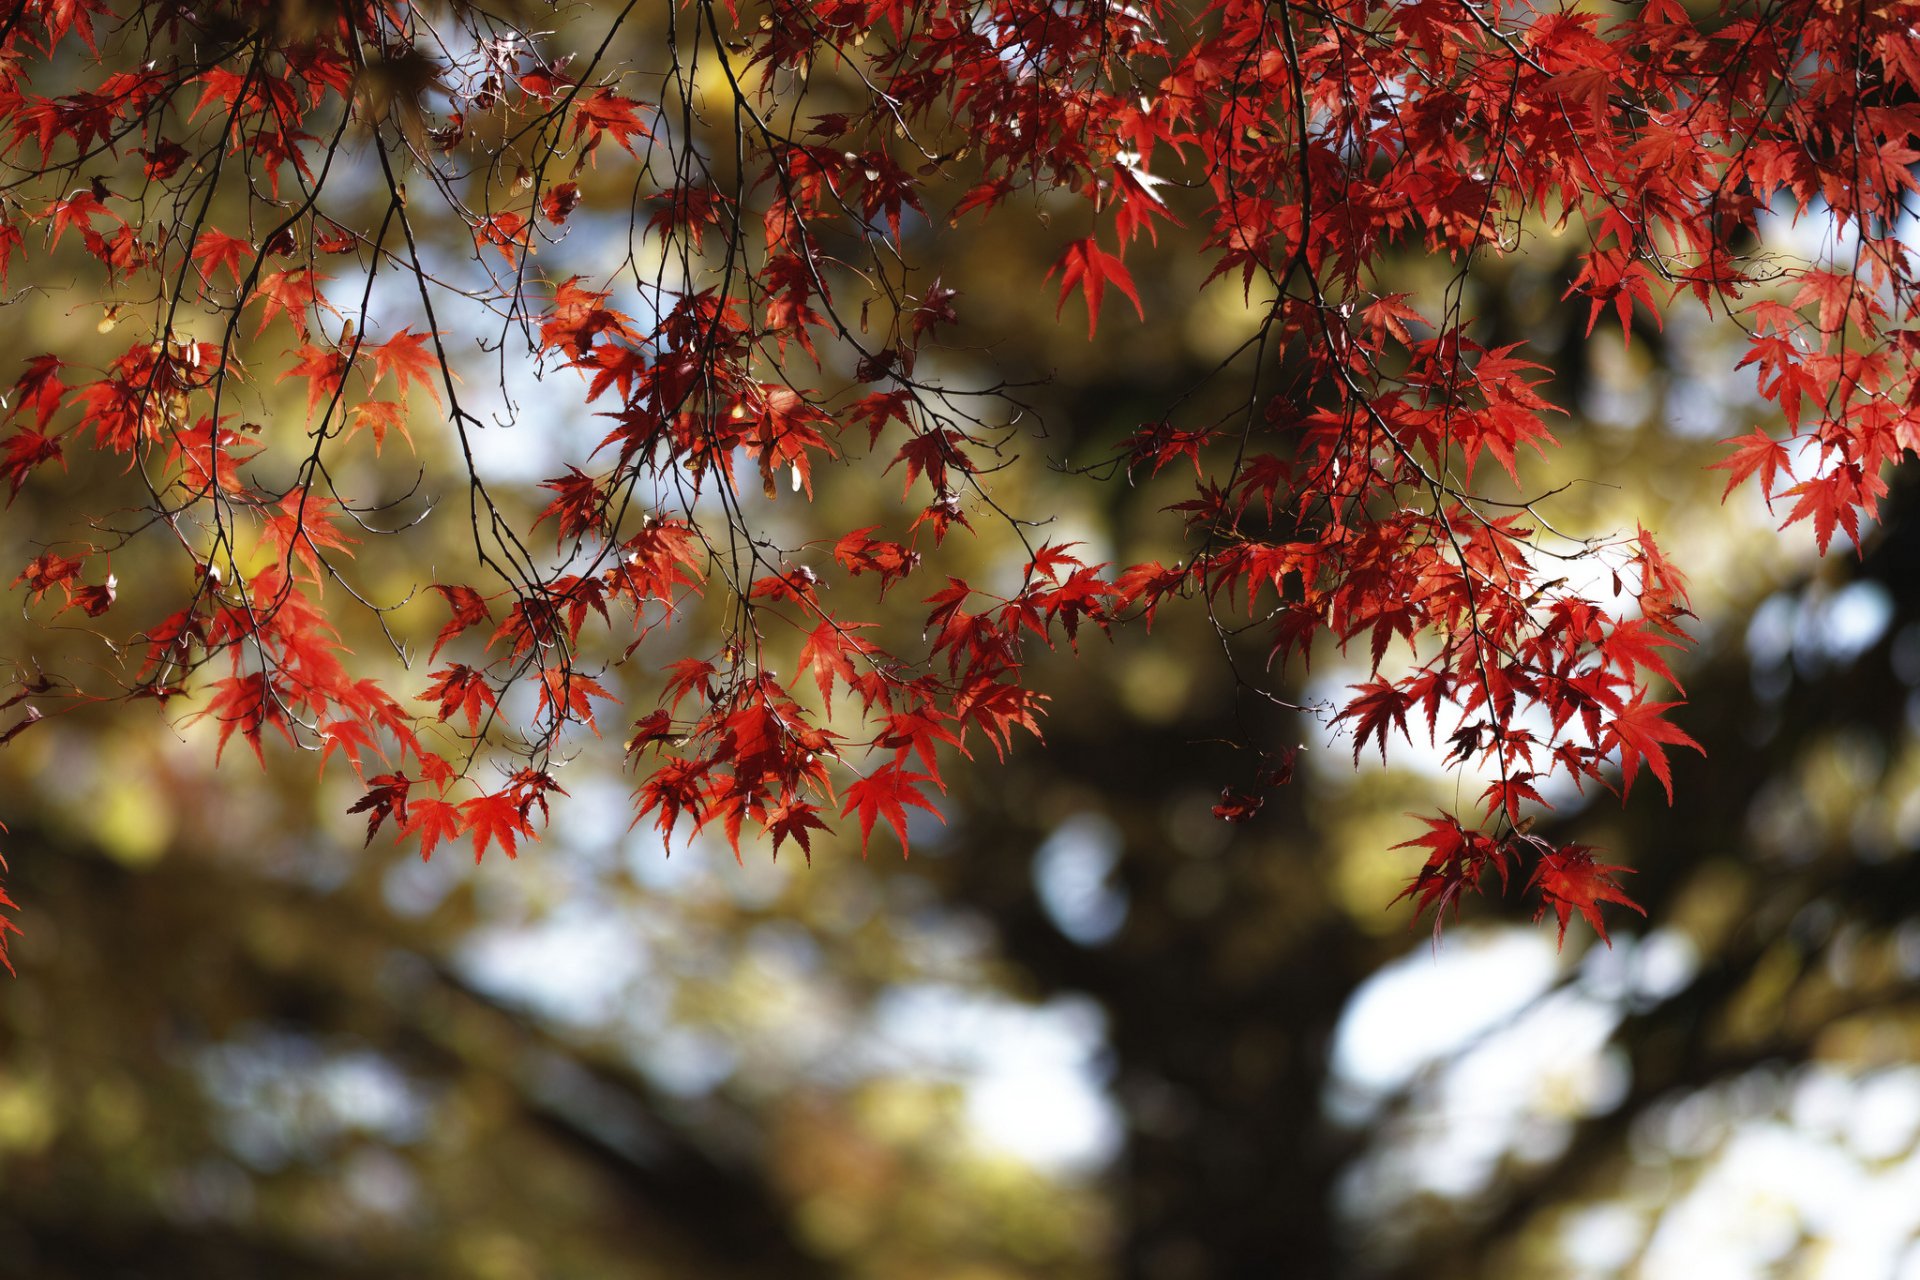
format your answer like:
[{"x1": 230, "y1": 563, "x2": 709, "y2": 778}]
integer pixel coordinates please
[{"x1": 0, "y1": 0, "x2": 1920, "y2": 974}]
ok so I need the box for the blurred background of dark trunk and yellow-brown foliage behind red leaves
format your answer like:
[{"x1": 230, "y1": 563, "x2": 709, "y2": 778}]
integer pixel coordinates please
[{"x1": 0, "y1": 0, "x2": 1920, "y2": 1280}]
